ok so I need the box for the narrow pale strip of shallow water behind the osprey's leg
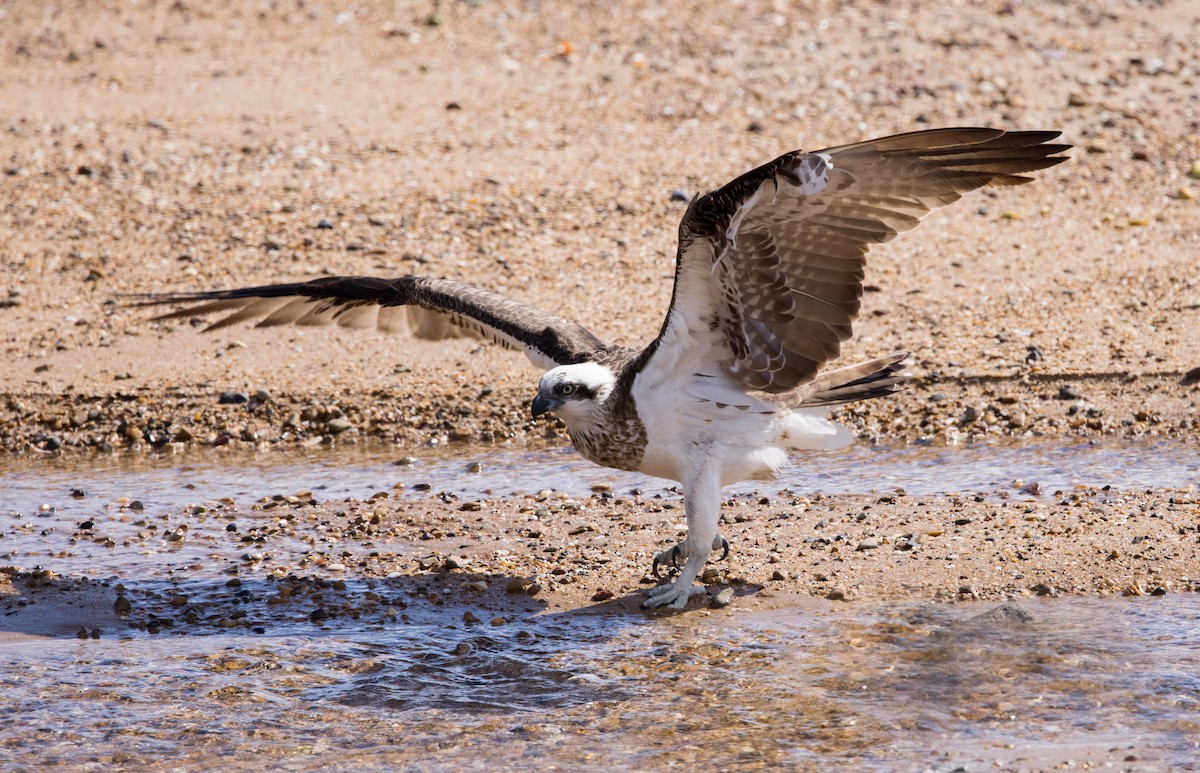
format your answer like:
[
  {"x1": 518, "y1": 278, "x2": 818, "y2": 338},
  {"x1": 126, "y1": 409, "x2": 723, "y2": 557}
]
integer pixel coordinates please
[{"x1": 0, "y1": 439, "x2": 1200, "y2": 515}]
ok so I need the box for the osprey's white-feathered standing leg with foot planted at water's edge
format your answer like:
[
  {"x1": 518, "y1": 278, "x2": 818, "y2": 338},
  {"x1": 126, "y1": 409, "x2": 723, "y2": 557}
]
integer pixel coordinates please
[{"x1": 642, "y1": 459, "x2": 727, "y2": 610}]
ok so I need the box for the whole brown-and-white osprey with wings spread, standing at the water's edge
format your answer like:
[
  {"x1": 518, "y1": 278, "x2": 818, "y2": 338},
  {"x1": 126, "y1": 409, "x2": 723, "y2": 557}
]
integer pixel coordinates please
[{"x1": 140, "y1": 128, "x2": 1070, "y2": 610}]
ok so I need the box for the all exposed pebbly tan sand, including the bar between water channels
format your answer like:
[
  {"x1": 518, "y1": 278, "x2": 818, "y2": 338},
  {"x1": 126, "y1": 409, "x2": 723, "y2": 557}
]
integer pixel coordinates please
[{"x1": 0, "y1": 0, "x2": 1200, "y2": 603}]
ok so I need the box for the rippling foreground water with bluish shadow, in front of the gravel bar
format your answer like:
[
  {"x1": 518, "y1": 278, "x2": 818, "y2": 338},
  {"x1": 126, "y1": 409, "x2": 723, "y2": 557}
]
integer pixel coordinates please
[{"x1": 0, "y1": 595, "x2": 1200, "y2": 771}]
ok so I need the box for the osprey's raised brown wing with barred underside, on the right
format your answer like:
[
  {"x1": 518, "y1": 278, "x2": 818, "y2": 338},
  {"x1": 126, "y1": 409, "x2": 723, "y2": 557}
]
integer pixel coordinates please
[{"x1": 641, "y1": 128, "x2": 1070, "y2": 394}]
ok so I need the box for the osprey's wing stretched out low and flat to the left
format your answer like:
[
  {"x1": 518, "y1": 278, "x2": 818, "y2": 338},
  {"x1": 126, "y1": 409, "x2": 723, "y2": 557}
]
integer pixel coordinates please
[{"x1": 134, "y1": 276, "x2": 605, "y2": 370}]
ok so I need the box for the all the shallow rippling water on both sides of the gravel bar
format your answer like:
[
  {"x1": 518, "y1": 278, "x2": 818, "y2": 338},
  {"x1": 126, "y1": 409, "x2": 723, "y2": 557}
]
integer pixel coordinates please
[{"x1": 0, "y1": 442, "x2": 1200, "y2": 771}]
